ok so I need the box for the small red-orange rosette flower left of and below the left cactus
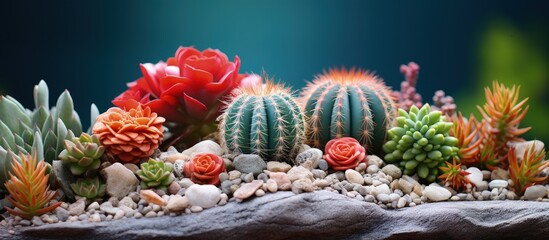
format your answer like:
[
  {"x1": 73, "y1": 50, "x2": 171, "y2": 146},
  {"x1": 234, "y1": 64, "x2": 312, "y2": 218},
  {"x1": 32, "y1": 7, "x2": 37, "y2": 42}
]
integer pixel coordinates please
[{"x1": 184, "y1": 153, "x2": 225, "y2": 185}]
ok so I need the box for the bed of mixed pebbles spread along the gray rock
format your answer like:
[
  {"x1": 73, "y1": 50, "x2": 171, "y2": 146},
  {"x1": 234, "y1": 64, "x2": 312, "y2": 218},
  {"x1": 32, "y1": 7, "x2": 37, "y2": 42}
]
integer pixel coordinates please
[{"x1": 0, "y1": 141, "x2": 549, "y2": 231}]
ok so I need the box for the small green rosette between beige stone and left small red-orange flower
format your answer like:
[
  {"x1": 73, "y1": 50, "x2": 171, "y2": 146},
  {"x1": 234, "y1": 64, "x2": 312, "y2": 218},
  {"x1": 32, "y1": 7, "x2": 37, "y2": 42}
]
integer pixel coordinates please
[{"x1": 136, "y1": 158, "x2": 175, "y2": 190}]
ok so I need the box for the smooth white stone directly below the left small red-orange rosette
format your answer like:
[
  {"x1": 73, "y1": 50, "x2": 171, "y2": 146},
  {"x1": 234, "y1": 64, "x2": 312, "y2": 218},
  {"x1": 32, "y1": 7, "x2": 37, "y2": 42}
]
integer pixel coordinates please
[{"x1": 185, "y1": 184, "x2": 221, "y2": 208}]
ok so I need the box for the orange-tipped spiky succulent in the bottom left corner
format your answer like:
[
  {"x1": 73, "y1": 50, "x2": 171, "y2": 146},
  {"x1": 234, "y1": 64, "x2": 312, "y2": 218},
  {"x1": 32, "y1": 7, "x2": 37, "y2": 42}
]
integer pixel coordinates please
[{"x1": 5, "y1": 153, "x2": 61, "y2": 219}]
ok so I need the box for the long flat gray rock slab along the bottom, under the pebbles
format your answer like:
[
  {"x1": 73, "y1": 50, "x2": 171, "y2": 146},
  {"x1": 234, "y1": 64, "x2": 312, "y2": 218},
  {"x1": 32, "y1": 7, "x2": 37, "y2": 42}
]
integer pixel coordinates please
[{"x1": 4, "y1": 191, "x2": 549, "y2": 240}]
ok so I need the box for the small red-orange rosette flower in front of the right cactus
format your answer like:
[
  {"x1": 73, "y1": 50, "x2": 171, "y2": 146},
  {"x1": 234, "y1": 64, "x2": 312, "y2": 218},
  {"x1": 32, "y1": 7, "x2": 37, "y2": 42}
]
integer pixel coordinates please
[{"x1": 324, "y1": 137, "x2": 368, "y2": 171}]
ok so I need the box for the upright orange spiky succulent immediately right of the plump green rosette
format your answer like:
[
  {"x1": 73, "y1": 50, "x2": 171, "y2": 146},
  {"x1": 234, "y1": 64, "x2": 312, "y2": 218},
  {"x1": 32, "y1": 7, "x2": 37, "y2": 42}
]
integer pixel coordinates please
[{"x1": 450, "y1": 113, "x2": 482, "y2": 166}]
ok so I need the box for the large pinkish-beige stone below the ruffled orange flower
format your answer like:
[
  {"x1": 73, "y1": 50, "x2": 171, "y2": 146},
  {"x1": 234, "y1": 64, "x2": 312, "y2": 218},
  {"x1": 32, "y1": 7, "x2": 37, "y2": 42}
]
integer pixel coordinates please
[{"x1": 101, "y1": 163, "x2": 139, "y2": 199}]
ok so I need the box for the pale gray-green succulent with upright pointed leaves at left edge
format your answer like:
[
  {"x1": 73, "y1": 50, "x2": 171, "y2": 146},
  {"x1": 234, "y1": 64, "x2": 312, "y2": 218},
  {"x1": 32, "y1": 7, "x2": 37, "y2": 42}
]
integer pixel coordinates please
[{"x1": 0, "y1": 81, "x2": 98, "y2": 187}]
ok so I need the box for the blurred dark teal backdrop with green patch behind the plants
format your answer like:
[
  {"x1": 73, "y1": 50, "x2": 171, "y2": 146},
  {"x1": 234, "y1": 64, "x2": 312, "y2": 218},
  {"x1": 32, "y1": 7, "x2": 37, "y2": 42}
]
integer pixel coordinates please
[{"x1": 0, "y1": 0, "x2": 549, "y2": 141}]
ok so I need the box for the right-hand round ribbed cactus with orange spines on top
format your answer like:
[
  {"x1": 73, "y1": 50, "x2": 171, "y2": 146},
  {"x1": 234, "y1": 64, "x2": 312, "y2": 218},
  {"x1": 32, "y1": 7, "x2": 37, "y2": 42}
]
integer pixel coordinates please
[{"x1": 300, "y1": 68, "x2": 396, "y2": 154}]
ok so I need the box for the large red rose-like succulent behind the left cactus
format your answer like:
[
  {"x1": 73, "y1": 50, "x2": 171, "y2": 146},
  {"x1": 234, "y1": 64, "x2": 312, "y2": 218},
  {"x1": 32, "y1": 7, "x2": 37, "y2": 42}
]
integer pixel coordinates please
[{"x1": 112, "y1": 47, "x2": 246, "y2": 149}]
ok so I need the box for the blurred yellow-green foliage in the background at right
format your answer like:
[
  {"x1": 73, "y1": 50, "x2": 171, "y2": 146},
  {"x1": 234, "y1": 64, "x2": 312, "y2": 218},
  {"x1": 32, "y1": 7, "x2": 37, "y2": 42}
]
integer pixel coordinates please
[{"x1": 456, "y1": 19, "x2": 549, "y2": 144}]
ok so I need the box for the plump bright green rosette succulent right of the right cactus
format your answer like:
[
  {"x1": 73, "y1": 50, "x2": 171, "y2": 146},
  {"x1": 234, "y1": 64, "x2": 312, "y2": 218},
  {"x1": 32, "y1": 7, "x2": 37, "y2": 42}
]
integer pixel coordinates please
[{"x1": 383, "y1": 104, "x2": 459, "y2": 182}]
